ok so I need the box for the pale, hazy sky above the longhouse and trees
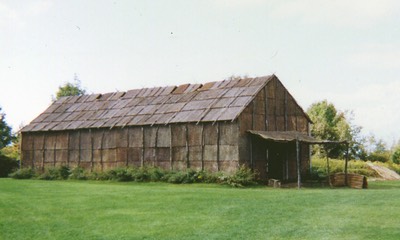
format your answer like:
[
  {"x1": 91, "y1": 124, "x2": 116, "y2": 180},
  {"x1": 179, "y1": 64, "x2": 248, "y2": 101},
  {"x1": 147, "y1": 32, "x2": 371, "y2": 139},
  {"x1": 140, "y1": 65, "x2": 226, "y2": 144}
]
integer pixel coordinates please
[{"x1": 0, "y1": 0, "x2": 400, "y2": 146}]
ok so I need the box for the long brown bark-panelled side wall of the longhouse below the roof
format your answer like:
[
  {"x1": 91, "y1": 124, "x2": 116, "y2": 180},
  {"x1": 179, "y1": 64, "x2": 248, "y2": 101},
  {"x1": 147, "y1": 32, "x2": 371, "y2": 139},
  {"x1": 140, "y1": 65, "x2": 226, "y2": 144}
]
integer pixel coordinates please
[{"x1": 23, "y1": 122, "x2": 239, "y2": 172}]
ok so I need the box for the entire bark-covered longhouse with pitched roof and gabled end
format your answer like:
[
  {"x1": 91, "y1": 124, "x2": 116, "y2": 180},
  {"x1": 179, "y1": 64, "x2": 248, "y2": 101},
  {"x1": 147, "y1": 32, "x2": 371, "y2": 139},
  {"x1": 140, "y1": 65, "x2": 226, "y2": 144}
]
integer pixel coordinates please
[{"x1": 21, "y1": 75, "x2": 311, "y2": 180}]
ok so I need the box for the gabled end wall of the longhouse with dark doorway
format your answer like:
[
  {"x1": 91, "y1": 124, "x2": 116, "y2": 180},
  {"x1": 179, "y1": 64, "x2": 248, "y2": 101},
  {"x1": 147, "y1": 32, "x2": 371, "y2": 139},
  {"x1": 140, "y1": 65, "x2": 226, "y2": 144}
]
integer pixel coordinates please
[{"x1": 238, "y1": 78, "x2": 310, "y2": 180}]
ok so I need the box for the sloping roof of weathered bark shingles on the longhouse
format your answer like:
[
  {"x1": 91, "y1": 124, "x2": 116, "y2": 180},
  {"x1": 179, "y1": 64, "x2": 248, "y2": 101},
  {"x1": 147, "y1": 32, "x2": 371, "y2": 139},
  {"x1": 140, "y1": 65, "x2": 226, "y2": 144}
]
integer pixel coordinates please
[{"x1": 21, "y1": 75, "x2": 275, "y2": 132}]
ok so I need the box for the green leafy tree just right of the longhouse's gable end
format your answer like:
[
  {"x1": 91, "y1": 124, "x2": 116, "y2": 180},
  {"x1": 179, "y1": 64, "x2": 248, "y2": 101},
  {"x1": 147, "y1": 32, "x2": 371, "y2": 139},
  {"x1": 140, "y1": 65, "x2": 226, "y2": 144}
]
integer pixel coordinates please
[{"x1": 307, "y1": 100, "x2": 365, "y2": 158}]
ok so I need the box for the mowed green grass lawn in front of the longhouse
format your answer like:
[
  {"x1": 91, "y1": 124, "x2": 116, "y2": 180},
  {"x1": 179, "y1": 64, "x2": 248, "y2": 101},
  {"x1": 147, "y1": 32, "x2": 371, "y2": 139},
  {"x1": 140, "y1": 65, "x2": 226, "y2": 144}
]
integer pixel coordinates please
[{"x1": 0, "y1": 179, "x2": 400, "y2": 239}]
